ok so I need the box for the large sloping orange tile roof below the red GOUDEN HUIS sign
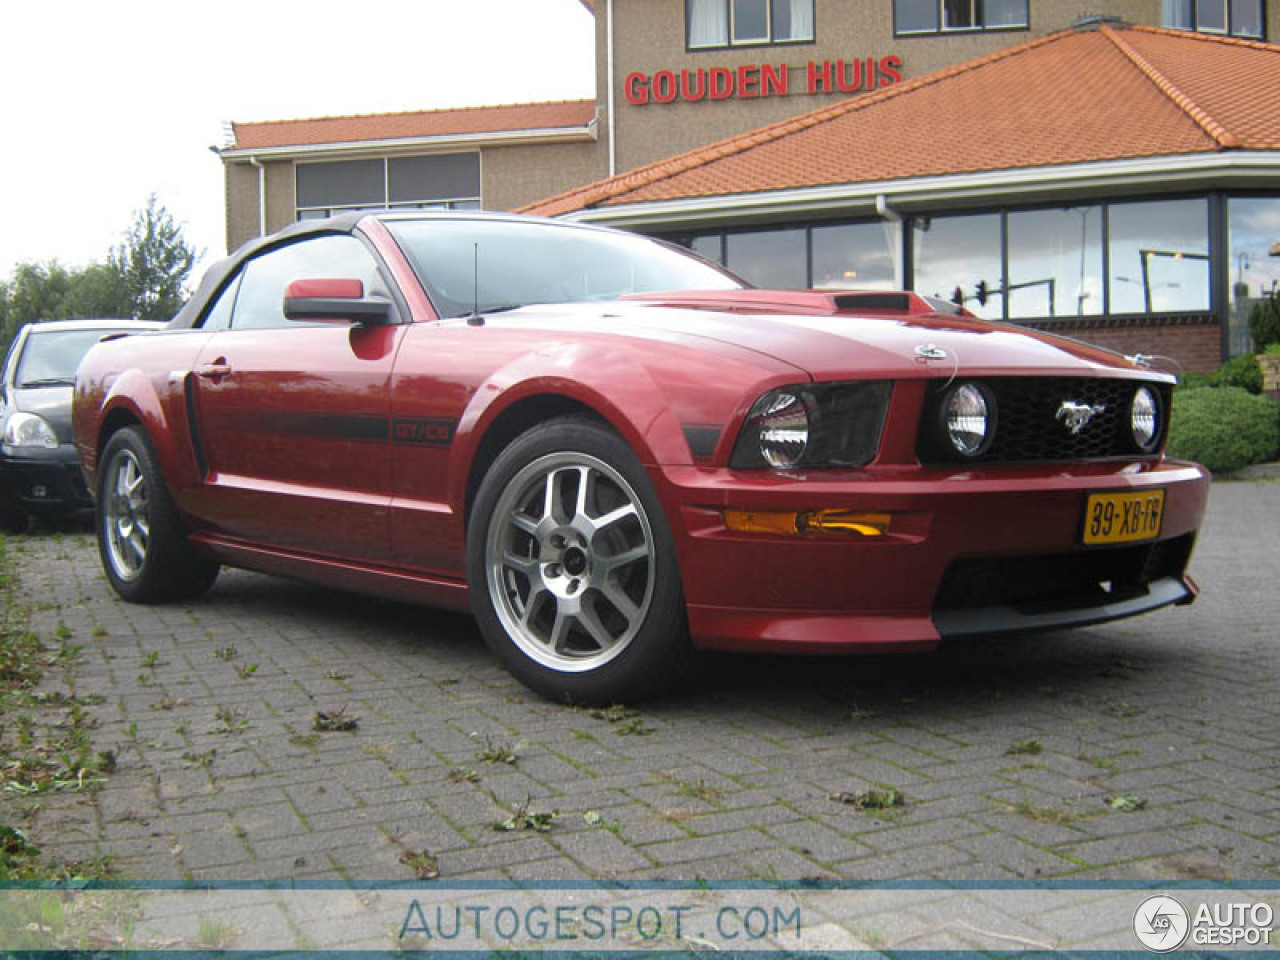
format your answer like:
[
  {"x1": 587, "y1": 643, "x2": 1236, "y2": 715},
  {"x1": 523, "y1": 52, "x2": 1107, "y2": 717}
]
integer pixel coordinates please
[{"x1": 524, "y1": 24, "x2": 1280, "y2": 216}]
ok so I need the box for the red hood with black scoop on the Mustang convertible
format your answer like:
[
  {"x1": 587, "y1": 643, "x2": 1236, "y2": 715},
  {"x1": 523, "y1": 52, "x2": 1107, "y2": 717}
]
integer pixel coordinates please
[{"x1": 481, "y1": 291, "x2": 1158, "y2": 380}]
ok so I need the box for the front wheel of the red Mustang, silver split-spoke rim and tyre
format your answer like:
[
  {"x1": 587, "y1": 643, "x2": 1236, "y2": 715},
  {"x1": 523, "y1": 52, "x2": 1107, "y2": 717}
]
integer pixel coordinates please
[{"x1": 467, "y1": 417, "x2": 690, "y2": 704}]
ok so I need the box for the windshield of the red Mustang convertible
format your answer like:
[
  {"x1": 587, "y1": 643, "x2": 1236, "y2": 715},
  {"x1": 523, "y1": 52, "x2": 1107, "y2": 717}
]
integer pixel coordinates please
[{"x1": 387, "y1": 219, "x2": 742, "y2": 317}]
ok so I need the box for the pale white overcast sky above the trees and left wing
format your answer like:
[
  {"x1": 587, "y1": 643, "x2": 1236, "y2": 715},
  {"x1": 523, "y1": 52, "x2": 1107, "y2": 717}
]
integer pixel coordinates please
[{"x1": 0, "y1": 0, "x2": 595, "y2": 280}]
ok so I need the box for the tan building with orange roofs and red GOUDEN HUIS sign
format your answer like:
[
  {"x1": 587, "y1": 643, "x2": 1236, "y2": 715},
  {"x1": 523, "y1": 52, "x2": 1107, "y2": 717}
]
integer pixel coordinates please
[{"x1": 221, "y1": 0, "x2": 1280, "y2": 371}]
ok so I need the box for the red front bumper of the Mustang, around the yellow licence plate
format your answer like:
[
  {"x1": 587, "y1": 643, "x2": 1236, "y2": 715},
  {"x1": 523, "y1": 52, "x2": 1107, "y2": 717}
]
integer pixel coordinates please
[{"x1": 653, "y1": 461, "x2": 1208, "y2": 653}]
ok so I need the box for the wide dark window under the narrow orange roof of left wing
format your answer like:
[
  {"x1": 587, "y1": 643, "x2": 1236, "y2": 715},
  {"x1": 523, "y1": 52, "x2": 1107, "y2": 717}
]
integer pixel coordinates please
[{"x1": 294, "y1": 154, "x2": 480, "y2": 220}]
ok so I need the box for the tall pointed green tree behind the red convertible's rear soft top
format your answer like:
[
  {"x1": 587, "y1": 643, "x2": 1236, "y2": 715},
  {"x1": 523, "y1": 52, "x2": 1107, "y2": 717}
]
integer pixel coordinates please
[{"x1": 106, "y1": 193, "x2": 196, "y2": 320}]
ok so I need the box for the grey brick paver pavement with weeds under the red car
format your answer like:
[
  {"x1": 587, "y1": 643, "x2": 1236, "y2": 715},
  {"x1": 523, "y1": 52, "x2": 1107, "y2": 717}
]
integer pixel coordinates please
[{"x1": 0, "y1": 483, "x2": 1280, "y2": 879}]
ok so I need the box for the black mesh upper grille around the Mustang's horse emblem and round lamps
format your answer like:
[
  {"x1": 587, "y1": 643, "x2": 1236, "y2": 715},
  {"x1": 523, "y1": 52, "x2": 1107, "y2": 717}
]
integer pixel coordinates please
[{"x1": 916, "y1": 376, "x2": 1171, "y2": 463}]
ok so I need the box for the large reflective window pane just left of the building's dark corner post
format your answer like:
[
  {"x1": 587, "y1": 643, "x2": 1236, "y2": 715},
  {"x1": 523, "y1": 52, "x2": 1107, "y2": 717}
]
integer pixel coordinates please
[{"x1": 1108, "y1": 198, "x2": 1210, "y2": 314}]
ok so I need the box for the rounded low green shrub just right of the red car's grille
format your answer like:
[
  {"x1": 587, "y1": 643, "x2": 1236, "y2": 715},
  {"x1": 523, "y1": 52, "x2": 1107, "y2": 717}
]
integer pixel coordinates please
[{"x1": 1169, "y1": 387, "x2": 1280, "y2": 474}]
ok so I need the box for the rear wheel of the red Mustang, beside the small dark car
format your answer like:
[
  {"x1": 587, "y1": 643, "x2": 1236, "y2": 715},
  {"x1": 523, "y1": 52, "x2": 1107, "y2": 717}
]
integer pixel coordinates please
[{"x1": 97, "y1": 426, "x2": 218, "y2": 603}]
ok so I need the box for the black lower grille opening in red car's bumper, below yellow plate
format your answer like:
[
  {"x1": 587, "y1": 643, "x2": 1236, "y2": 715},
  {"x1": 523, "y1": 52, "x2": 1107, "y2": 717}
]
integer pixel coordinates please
[{"x1": 934, "y1": 534, "x2": 1192, "y2": 613}]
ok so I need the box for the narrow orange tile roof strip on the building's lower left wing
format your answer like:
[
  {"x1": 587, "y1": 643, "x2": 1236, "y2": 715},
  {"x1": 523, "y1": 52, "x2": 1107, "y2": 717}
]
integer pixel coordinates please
[{"x1": 230, "y1": 100, "x2": 595, "y2": 150}]
